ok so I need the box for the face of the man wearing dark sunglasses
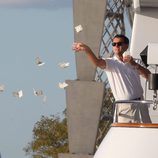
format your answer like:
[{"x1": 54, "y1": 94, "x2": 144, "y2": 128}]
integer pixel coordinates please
[{"x1": 113, "y1": 37, "x2": 128, "y2": 55}]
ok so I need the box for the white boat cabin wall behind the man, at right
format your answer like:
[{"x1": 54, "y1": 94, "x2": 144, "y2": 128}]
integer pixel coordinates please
[{"x1": 130, "y1": 1, "x2": 158, "y2": 122}]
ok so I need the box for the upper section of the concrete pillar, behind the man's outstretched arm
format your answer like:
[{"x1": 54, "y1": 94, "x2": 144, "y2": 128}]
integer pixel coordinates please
[{"x1": 73, "y1": 0, "x2": 106, "y2": 81}]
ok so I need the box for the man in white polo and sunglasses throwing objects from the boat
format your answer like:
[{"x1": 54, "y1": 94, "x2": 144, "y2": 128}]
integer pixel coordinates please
[{"x1": 73, "y1": 35, "x2": 151, "y2": 123}]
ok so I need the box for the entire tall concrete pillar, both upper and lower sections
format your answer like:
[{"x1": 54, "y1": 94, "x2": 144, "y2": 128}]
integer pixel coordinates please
[{"x1": 59, "y1": 0, "x2": 106, "y2": 158}]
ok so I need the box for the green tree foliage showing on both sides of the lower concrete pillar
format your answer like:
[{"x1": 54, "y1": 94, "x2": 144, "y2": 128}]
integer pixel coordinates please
[{"x1": 24, "y1": 82, "x2": 114, "y2": 158}]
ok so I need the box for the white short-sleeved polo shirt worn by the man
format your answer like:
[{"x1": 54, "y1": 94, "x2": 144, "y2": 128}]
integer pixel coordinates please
[{"x1": 105, "y1": 56, "x2": 143, "y2": 100}]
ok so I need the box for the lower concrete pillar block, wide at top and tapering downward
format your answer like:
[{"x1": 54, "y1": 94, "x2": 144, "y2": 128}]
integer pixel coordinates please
[{"x1": 66, "y1": 80, "x2": 104, "y2": 154}]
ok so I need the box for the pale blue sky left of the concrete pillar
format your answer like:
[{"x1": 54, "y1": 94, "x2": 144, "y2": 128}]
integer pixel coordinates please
[{"x1": 0, "y1": 0, "x2": 76, "y2": 158}]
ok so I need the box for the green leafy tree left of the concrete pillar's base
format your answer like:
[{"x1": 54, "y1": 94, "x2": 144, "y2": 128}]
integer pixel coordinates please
[{"x1": 24, "y1": 116, "x2": 68, "y2": 158}]
